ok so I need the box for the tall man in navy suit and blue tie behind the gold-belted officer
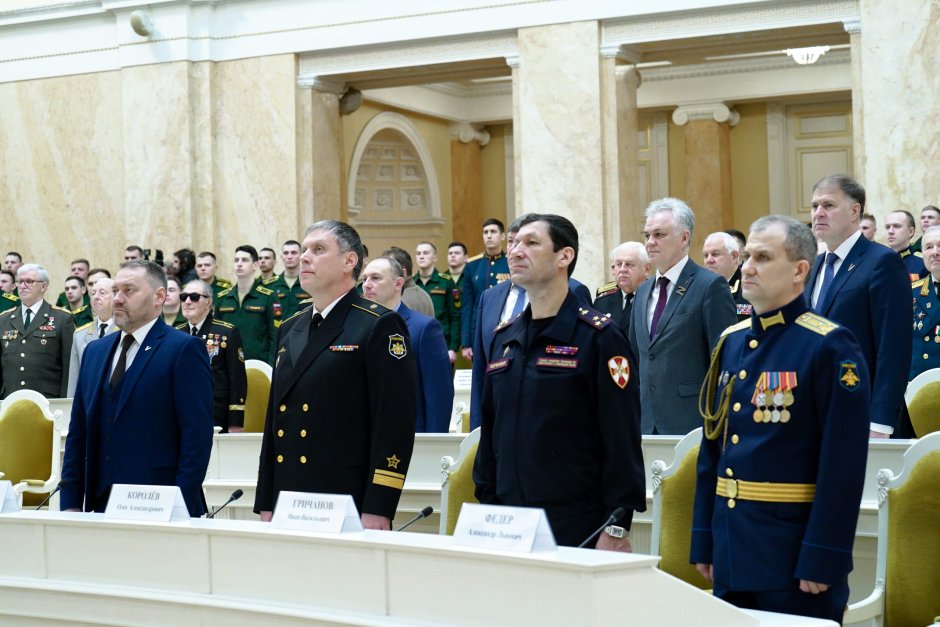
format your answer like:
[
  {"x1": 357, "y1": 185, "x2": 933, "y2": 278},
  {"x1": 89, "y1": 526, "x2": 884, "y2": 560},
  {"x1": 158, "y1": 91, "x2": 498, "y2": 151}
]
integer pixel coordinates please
[{"x1": 804, "y1": 174, "x2": 912, "y2": 438}]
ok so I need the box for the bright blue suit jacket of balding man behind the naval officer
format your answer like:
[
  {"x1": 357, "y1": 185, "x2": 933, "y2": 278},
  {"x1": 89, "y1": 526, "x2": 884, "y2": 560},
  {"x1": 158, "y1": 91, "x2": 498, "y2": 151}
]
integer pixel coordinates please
[{"x1": 398, "y1": 303, "x2": 454, "y2": 433}]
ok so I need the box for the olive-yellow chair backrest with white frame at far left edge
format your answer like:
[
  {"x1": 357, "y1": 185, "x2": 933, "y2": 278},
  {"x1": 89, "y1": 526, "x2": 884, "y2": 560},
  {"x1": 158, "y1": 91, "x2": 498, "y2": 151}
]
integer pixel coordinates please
[{"x1": 0, "y1": 390, "x2": 59, "y2": 505}]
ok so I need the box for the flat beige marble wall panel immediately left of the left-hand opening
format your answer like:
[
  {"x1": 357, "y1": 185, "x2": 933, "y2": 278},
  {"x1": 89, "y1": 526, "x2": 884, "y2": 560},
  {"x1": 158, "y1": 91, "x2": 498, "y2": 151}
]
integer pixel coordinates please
[{"x1": 212, "y1": 55, "x2": 304, "y2": 255}]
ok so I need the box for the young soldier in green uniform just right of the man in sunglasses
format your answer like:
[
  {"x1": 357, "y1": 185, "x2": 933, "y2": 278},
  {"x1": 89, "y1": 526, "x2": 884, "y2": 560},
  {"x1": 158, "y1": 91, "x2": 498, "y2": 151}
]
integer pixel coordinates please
[{"x1": 215, "y1": 244, "x2": 281, "y2": 365}]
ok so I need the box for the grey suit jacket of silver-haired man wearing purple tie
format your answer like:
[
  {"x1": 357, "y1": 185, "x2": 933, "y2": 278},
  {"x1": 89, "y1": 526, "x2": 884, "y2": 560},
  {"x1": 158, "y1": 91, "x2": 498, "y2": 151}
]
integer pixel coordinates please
[{"x1": 629, "y1": 259, "x2": 738, "y2": 435}]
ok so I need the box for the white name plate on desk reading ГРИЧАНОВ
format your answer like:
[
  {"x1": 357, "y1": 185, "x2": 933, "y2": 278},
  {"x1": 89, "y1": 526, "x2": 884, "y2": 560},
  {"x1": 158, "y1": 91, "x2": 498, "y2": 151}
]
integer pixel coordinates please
[{"x1": 271, "y1": 492, "x2": 362, "y2": 533}]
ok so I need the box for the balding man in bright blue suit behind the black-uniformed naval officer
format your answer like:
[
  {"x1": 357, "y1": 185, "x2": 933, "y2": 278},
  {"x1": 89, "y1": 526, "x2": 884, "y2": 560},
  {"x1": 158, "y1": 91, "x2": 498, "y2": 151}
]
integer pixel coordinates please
[{"x1": 362, "y1": 257, "x2": 454, "y2": 433}]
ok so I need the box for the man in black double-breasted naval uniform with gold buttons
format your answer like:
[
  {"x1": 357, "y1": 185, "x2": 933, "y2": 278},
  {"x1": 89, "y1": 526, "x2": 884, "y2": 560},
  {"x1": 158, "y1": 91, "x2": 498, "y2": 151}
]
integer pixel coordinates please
[{"x1": 255, "y1": 220, "x2": 418, "y2": 529}]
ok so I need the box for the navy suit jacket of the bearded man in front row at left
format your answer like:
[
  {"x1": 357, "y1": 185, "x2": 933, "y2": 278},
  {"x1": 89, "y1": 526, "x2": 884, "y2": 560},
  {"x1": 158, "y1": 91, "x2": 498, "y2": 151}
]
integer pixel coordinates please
[{"x1": 61, "y1": 318, "x2": 212, "y2": 516}]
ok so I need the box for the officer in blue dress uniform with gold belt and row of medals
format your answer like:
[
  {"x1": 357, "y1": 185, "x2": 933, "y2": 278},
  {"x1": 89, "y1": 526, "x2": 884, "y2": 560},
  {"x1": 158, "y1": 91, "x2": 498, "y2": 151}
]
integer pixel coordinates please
[{"x1": 691, "y1": 216, "x2": 870, "y2": 622}]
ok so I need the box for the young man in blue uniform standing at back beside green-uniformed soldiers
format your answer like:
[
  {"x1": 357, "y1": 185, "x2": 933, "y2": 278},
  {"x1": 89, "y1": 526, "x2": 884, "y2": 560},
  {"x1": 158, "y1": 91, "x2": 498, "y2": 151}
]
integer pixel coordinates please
[{"x1": 460, "y1": 218, "x2": 509, "y2": 359}]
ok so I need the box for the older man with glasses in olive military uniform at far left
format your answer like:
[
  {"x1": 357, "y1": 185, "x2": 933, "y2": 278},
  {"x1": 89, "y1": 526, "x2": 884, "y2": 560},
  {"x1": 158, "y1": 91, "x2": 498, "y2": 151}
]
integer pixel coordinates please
[{"x1": 0, "y1": 263, "x2": 75, "y2": 398}]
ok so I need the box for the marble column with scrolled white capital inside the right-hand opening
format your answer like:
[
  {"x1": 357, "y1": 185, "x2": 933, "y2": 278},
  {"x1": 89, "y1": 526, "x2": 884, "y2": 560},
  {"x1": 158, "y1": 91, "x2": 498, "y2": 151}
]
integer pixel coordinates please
[{"x1": 672, "y1": 102, "x2": 740, "y2": 259}]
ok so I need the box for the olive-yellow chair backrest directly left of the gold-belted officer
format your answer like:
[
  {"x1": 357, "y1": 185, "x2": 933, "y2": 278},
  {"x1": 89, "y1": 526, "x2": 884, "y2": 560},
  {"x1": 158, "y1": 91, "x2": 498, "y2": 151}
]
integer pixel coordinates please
[{"x1": 650, "y1": 428, "x2": 711, "y2": 590}]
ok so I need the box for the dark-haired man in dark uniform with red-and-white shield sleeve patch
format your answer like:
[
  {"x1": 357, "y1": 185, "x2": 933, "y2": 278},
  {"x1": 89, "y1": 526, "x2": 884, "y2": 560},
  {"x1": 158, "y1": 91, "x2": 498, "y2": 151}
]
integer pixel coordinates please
[{"x1": 473, "y1": 214, "x2": 646, "y2": 551}]
